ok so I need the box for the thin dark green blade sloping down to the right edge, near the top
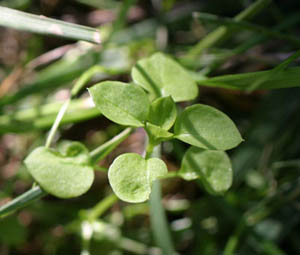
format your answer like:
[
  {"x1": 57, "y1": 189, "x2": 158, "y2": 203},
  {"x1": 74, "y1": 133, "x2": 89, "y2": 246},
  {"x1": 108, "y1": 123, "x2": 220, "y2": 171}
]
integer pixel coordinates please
[{"x1": 193, "y1": 12, "x2": 300, "y2": 46}]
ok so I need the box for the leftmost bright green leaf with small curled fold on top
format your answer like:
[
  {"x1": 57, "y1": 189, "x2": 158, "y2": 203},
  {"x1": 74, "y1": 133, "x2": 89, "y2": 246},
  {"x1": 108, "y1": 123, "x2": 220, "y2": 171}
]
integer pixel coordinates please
[{"x1": 25, "y1": 142, "x2": 94, "y2": 198}]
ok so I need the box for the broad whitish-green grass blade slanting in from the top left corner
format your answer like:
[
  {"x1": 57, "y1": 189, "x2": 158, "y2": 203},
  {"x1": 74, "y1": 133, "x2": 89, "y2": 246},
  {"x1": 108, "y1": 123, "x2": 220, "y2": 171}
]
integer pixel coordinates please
[{"x1": 0, "y1": 7, "x2": 101, "y2": 44}]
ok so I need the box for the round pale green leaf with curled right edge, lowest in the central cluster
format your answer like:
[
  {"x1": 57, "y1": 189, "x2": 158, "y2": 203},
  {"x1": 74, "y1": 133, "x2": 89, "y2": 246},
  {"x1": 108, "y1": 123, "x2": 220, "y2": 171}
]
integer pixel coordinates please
[{"x1": 108, "y1": 153, "x2": 168, "y2": 203}]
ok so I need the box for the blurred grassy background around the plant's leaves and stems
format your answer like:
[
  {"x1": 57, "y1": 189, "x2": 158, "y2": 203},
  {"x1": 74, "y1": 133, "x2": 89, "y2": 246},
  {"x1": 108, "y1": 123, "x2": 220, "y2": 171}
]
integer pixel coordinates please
[{"x1": 0, "y1": 0, "x2": 300, "y2": 255}]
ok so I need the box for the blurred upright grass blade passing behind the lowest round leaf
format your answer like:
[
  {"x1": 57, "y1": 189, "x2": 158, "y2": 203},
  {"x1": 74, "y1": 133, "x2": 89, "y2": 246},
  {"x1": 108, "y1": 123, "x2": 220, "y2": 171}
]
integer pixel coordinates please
[{"x1": 145, "y1": 143, "x2": 176, "y2": 255}]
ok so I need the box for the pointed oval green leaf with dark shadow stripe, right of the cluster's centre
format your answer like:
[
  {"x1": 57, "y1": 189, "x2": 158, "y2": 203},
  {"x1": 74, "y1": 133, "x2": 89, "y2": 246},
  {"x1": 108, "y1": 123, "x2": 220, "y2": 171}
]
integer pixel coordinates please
[{"x1": 175, "y1": 104, "x2": 243, "y2": 150}]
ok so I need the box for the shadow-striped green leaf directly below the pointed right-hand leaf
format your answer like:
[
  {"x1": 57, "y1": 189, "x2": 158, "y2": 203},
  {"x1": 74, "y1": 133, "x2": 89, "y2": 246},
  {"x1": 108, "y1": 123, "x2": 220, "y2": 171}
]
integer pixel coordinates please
[{"x1": 178, "y1": 147, "x2": 232, "y2": 194}]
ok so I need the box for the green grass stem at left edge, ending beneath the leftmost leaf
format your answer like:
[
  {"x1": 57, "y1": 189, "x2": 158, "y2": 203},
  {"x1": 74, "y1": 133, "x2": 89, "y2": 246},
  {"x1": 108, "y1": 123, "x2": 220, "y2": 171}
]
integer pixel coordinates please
[{"x1": 0, "y1": 186, "x2": 47, "y2": 218}]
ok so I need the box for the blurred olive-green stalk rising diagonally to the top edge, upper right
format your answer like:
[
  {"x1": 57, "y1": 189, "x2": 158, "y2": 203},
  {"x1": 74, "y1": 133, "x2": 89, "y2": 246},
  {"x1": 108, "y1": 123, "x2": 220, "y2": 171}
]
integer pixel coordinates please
[{"x1": 187, "y1": 0, "x2": 271, "y2": 57}]
